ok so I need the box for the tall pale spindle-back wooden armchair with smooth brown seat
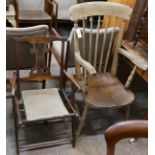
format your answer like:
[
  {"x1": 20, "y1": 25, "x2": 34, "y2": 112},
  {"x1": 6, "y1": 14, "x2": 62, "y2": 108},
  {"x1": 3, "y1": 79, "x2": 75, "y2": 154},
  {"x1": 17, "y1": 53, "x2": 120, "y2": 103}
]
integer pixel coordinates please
[{"x1": 64, "y1": 2, "x2": 135, "y2": 143}]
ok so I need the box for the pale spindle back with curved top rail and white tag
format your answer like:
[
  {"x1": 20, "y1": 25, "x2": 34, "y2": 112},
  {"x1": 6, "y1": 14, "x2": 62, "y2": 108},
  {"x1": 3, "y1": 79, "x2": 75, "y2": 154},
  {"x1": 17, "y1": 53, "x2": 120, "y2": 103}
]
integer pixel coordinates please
[{"x1": 69, "y1": 2, "x2": 132, "y2": 78}]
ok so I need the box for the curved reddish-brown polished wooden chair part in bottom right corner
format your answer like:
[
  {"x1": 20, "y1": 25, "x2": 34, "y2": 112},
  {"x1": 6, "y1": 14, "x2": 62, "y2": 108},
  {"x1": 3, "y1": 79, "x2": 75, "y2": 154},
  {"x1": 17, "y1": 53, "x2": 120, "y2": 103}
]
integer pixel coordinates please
[{"x1": 104, "y1": 120, "x2": 148, "y2": 155}]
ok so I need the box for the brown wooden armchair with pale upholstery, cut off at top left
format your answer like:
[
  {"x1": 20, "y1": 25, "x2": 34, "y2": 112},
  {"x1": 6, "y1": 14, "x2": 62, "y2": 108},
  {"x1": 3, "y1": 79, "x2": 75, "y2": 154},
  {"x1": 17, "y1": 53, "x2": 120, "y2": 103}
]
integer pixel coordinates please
[{"x1": 13, "y1": 0, "x2": 58, "y2": 30}]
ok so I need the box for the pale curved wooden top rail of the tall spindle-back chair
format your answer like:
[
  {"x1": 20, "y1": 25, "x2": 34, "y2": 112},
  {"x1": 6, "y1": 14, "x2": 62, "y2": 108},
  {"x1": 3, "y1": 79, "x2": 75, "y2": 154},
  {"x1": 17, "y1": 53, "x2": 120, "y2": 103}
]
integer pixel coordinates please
[{"x1": 69, "y1": 2, "x2": 132, "y2": 21}]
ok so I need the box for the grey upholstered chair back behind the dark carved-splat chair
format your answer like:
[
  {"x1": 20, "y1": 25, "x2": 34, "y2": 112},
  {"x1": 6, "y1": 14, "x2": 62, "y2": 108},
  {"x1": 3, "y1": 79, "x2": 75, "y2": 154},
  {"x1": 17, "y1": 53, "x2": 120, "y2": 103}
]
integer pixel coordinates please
[{"x1": 6, "y1": 25, "x2": 48, "y2": 70}]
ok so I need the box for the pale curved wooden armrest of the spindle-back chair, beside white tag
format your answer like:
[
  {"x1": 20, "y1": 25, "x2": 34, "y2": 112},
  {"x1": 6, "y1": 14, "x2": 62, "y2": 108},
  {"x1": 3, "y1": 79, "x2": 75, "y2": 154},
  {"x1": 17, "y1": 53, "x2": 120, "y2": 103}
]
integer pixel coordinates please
[{"x1": 75, "y1": 51, "x2": 96, "y2": 75}]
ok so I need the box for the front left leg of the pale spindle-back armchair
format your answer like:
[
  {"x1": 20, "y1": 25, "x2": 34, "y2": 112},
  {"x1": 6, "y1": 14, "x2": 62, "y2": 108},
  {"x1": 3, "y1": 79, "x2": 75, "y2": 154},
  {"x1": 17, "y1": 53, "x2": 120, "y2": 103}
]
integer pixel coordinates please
[{"x1": 75, "y1": 103, "x2": 88, "y2": 142}]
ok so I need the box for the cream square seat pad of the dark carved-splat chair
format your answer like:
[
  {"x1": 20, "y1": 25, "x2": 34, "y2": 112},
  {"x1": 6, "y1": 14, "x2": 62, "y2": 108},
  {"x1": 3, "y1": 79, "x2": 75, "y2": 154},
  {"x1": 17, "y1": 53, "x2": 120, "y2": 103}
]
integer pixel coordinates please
[{"x1": 22, "y1": 88, "x2": 69, "y2": 121}]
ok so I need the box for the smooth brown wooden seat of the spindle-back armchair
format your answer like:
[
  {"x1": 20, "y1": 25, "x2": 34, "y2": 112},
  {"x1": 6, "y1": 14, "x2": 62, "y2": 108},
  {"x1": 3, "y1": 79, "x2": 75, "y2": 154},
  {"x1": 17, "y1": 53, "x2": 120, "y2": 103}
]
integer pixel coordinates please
[{"x1": 86, "y1": 73, "x2": 134, "y2": 108}]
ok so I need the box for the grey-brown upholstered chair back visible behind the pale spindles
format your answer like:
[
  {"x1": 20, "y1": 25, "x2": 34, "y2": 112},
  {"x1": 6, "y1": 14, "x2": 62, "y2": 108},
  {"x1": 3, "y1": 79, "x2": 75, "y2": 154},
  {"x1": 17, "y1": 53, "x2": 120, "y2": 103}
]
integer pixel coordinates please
[{"x1": 67, "y1": 27, "x2": 119, "y2": 70}]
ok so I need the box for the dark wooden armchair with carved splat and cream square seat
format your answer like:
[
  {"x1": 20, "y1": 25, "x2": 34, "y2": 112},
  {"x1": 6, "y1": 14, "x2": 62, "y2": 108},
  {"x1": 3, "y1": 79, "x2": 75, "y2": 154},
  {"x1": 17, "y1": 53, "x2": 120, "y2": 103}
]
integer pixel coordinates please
[{"x1": 10, "y1": 31, "x2": 76, "y2": 154}]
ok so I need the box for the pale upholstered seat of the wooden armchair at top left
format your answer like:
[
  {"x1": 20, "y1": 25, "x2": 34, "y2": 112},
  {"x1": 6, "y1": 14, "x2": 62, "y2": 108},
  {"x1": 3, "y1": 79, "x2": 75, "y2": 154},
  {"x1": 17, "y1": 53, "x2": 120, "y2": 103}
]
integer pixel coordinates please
[{"x1": 19, "y1": 10, "x2": 51, "y2": 20}]
